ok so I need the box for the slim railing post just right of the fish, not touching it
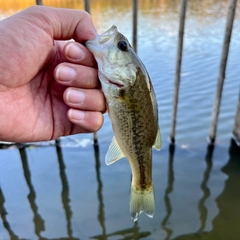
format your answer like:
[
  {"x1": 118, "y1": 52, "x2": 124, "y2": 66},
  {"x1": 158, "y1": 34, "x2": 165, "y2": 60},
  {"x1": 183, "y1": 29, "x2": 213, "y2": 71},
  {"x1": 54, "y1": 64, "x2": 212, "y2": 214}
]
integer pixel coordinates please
[{"x1": 170, "y1": 0, "x2": 187, "y2": 144}]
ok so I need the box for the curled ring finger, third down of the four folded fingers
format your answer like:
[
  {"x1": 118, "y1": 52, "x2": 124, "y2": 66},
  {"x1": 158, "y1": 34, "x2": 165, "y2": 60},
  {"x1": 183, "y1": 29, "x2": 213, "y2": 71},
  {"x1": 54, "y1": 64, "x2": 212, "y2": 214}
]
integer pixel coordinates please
[{"x1": 63, "y1": 87, "x2": 106, "y2": 112}]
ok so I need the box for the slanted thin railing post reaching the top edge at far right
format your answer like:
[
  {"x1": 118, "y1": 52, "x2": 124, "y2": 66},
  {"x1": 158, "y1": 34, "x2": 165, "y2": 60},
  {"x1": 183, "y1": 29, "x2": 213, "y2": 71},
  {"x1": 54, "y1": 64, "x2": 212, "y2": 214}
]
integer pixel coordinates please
[{"x1": 209, "y1": 0, "x2": 237, "y2": 144}]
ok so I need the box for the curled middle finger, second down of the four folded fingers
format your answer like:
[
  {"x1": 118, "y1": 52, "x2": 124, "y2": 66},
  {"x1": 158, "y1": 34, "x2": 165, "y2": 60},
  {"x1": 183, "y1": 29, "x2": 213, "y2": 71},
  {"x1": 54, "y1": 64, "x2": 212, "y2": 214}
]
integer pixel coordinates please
[{"x1": 54, "y1": 63, "x2": 100, "y2": 89}]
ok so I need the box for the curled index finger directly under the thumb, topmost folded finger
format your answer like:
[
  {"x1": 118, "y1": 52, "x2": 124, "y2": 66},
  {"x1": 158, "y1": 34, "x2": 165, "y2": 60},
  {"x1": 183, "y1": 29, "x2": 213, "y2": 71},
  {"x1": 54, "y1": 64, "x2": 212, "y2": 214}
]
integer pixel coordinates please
[{"x1": 63, "y1": 42, "x2": 97, "y2": 68}]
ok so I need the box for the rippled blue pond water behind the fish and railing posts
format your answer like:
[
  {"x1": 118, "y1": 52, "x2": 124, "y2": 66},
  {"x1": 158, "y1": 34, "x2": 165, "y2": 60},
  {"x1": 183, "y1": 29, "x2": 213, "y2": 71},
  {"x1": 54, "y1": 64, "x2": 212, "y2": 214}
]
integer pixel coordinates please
[{"x1": 0, "y1": 0, "x2": 240, "y2": 240}]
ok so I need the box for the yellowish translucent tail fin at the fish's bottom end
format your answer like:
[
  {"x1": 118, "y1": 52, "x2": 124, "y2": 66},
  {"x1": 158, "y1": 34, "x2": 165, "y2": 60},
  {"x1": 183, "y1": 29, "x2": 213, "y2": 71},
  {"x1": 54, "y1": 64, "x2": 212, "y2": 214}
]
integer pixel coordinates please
[{"x1": 130, "y1": 185, "x2": 155, "y2": 222}]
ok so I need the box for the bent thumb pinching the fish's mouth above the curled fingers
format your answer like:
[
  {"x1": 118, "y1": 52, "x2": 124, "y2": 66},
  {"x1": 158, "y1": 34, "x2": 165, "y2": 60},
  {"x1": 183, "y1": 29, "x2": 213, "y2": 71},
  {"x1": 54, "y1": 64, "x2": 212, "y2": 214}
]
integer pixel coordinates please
[{"x1": 22, "y1": 6, "x2": 96, "y2": 42}]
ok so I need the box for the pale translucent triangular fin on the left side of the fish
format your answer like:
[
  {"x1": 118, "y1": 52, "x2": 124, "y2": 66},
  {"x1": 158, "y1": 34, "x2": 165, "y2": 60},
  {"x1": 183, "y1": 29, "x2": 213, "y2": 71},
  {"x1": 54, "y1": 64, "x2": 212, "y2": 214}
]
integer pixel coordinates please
[{"x1": 105, "y1": 137, "x2": 125, "y2": 165}]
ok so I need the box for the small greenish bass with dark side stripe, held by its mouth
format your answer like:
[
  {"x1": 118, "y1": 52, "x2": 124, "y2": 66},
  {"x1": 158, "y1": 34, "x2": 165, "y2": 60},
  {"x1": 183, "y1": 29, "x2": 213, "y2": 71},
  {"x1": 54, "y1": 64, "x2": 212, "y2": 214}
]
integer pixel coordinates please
[{"x1": 86, "y1": 25, "x2": 162, "y2": 222}]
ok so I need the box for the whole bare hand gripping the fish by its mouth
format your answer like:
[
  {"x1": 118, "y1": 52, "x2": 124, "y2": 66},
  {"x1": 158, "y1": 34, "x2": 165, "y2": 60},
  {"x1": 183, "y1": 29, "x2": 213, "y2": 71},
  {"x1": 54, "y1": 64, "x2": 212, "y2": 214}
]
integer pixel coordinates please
[{"x1": 0, "y1": 6, "x2": 105, "y2": 142}]
